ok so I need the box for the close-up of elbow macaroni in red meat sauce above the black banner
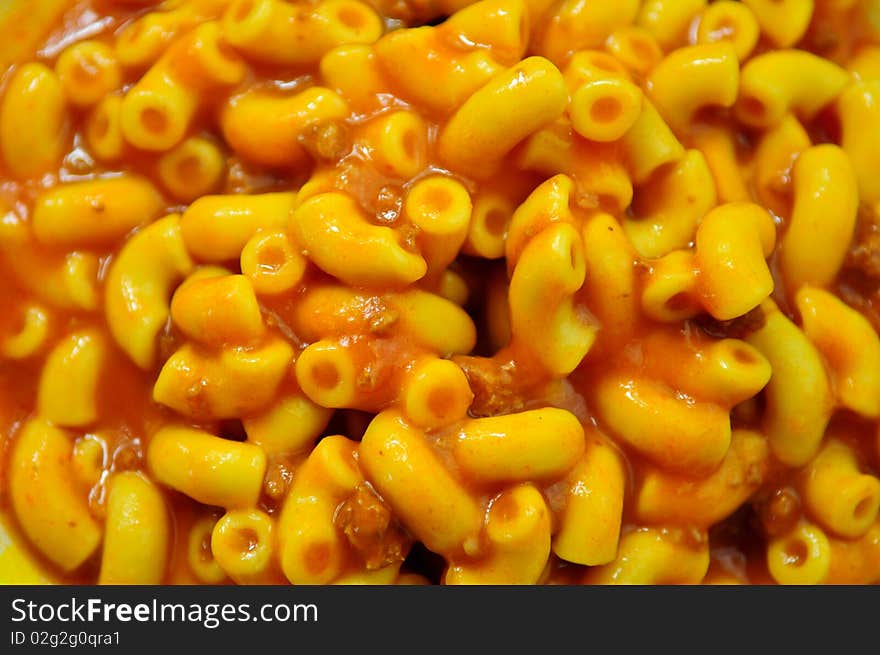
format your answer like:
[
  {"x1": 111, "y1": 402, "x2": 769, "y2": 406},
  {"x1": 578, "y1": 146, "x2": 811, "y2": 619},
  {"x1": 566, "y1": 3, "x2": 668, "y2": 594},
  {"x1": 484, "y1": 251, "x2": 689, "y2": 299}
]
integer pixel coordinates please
[{"x1": 0, "y1": 0, "x2": 880, "y2": 585}]
